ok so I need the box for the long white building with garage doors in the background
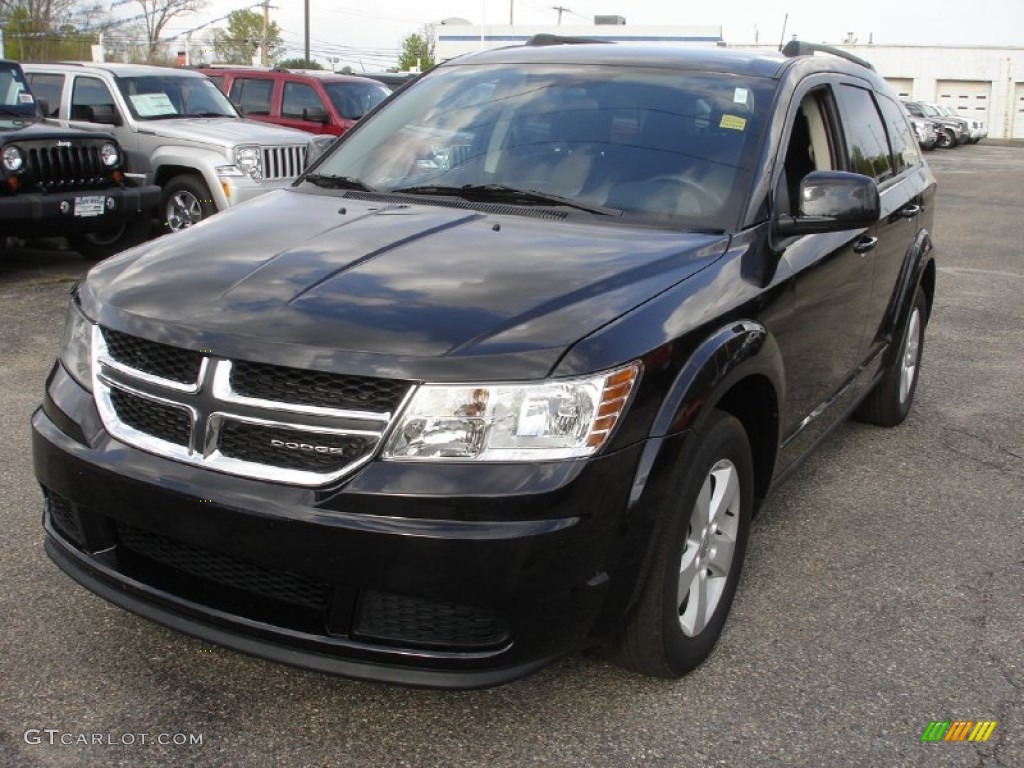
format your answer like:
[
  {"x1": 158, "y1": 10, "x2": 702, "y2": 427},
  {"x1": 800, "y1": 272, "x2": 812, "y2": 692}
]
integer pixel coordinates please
[{"x1": 435, "y1": 16, "x2": 1024, "y2": 139}]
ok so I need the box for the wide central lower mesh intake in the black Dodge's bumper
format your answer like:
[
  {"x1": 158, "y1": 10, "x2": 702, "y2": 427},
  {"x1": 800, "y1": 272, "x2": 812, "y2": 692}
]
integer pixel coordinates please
[{"x1": 118, "y1": 523, "x2": 330, "y2": 610}]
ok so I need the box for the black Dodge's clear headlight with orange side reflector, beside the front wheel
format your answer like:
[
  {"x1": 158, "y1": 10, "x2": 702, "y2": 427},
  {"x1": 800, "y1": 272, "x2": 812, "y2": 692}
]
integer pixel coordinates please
[{"x1": 384, "y1": 362, "x2": 640, "y2": 461}]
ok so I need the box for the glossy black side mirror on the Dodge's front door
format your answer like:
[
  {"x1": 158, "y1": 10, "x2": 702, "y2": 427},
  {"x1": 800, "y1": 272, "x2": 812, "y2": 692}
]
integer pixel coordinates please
[{"x1": 774, "y1": 171, "x2": 882, "y2": 238}]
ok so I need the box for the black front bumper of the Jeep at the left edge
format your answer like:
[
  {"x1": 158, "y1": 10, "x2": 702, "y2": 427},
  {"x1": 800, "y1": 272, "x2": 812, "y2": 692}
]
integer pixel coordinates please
[{"x1": 0, "y1": 184, "x2": 160, "y2": 237}]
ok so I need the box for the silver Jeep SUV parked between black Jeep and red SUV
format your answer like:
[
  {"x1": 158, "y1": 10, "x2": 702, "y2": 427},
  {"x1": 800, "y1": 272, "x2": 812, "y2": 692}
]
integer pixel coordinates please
[{"x1": 25, "y1": 62, "x2": 309, "y2": 231}]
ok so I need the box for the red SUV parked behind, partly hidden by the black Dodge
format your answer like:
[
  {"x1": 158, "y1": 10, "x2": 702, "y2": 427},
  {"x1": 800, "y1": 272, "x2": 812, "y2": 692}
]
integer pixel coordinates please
[{"x1": 200, "y1": 68, "x2": 390, "y2": 136}]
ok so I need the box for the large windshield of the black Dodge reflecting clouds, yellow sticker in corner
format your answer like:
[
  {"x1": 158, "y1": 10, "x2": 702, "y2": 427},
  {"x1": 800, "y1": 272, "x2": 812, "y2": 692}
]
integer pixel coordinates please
[{"x1": 315, "y1": 63, "x2": 774, "y2": 230}]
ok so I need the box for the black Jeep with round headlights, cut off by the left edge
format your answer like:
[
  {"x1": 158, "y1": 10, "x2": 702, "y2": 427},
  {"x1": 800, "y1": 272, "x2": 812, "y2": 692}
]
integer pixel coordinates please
[{"x1": 0, "y1": 60, "x2": 160, "y2": 259}]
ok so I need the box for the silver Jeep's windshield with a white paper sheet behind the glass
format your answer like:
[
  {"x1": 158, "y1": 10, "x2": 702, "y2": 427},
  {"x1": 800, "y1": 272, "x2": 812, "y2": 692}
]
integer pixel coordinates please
[{"x1": 118, "y1": 75, "x2": 239, "y2": 120}]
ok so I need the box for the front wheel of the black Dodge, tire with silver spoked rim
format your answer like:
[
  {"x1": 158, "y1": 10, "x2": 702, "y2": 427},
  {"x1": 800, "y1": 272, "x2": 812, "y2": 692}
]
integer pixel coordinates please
[{"x1": 617, "y1": 411, "x2": 754, "y2": 679}]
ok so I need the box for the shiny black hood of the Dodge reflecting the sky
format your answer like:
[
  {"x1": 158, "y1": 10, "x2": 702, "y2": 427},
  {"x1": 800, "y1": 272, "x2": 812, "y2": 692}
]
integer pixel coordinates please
[{"x1": 86, "y1": 189, "x2": 728, "y2": 381}]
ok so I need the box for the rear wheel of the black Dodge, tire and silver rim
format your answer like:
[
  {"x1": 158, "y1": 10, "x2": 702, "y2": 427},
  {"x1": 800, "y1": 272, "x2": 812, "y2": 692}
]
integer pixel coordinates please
[{"x1": 854, "y1": 286, "x2": 928, "y2": 427}]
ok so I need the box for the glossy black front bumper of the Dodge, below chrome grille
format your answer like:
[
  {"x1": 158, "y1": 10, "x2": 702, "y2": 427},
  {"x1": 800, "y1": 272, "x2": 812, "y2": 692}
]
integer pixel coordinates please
[{"x1": 33, "y1": 365, "x2": 659, "y2": 687}]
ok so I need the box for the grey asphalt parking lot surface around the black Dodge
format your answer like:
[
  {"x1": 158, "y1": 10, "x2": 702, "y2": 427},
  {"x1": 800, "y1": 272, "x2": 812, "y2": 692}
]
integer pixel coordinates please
[{"x1": 0, "y1": 142, "x2": 1024, "y2": 768}]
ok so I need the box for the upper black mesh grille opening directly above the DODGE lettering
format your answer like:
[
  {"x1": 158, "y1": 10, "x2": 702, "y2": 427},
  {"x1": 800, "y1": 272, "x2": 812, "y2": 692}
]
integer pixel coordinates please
[{"x1": 231, "y1": 361, "x2": 409, "y2": 413}]
